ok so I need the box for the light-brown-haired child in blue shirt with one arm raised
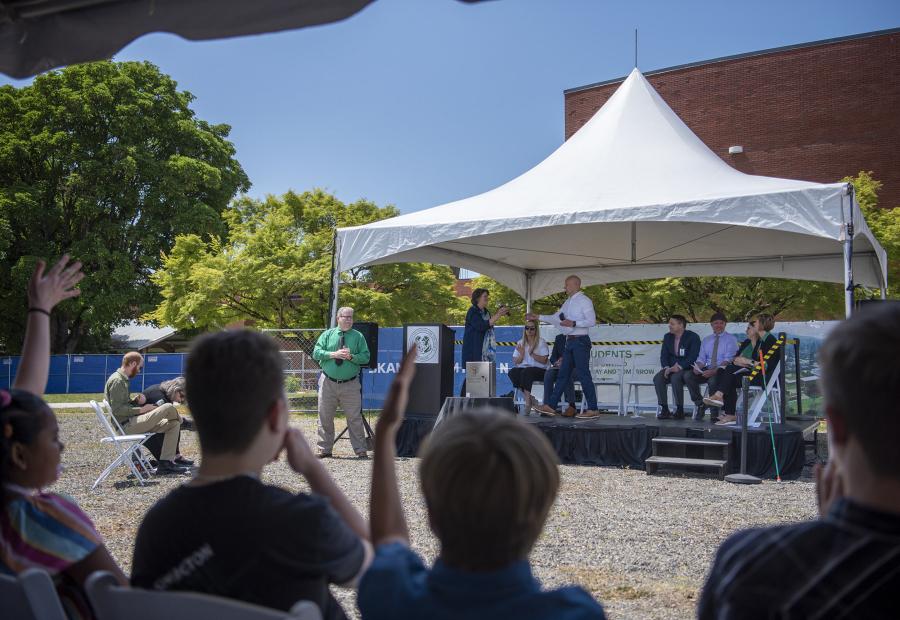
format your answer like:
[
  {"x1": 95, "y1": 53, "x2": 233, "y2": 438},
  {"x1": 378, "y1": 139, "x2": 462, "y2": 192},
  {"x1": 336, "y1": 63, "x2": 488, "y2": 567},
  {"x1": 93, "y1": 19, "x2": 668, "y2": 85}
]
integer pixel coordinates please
[{"x1": 356, "y1": 347, "x2": 604, "y2": 620}]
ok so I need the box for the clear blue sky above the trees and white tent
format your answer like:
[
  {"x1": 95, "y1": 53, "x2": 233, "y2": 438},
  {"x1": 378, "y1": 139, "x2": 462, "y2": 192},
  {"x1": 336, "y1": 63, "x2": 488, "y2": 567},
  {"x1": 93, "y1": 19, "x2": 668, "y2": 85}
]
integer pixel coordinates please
[{"x1": 0, "y1": 0, "x2": 900, "y2": 213}]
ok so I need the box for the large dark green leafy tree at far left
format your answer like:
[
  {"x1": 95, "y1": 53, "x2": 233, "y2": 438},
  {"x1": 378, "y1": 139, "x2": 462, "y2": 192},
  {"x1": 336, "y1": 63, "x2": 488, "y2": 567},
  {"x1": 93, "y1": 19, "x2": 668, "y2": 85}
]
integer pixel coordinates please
[{"x1": 0, "y1": 62, "x2": 250, "y2": 353}]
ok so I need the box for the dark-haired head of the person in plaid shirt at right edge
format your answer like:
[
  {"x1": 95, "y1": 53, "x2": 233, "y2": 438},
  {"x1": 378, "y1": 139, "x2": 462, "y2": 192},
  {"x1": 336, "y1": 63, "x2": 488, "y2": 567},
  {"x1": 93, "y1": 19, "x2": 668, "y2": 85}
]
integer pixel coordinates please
[{"x1": 819, "y1": 303, "x2": 900, "y2": 478}]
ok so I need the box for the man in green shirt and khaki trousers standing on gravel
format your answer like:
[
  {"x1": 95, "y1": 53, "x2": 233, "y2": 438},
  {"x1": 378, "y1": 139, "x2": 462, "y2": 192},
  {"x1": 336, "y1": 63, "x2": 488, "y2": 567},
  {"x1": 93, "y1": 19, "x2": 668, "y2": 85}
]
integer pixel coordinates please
[{"x1": 313, "y1": 307, "x2": 369, "y2": 459}]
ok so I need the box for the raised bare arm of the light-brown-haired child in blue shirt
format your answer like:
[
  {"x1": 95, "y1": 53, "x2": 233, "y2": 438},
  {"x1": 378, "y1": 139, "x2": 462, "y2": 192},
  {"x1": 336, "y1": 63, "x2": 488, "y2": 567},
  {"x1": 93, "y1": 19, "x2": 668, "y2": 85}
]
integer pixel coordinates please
[{"x1": 369, "y1": 345, "x2": 416, "y2": 547}]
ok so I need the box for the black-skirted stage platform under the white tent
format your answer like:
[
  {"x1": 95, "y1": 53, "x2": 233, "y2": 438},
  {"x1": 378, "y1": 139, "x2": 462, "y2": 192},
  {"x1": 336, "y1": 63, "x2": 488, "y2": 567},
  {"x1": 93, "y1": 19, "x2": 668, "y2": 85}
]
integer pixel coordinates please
[{"x1": 397, "y1": 414, "x2": 819, "y2": 480}]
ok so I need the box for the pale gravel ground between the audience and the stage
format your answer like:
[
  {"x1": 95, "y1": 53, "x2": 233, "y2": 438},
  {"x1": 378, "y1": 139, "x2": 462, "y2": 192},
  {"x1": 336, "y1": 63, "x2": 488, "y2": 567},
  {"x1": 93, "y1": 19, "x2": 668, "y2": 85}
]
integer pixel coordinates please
[{"x1": 52, "y1": 410, "x2": 827, "y2": 619}]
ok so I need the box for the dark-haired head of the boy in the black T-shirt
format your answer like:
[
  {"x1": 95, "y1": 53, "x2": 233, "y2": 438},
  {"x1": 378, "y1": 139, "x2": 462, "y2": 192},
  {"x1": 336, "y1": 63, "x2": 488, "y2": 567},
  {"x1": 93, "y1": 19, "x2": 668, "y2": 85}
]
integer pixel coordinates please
[{"x1": 185, "y1": 330, "x2": 284, "y2": 453}]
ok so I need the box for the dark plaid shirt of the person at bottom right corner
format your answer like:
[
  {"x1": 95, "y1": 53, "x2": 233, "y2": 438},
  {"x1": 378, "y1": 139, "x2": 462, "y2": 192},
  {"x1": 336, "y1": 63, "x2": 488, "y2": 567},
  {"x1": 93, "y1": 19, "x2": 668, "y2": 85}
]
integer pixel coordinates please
[{"x1": 698, "y1": 498, "x2": 900, "y2": 620}]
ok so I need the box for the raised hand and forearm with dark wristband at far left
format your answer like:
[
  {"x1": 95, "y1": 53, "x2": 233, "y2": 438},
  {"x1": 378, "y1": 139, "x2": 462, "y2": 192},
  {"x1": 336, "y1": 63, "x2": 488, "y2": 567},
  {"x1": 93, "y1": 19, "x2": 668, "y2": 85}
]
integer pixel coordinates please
[{"x1": 12, "y1": 254, "x2": 84, "y2": 396}]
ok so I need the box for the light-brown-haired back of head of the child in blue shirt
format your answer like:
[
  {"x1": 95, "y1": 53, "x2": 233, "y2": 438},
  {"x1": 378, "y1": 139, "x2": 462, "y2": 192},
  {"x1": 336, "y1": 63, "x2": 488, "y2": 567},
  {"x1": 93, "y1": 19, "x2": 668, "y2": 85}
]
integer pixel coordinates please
[{"x1": 419, "y1": 409, "x2": 559, "y2": 572}]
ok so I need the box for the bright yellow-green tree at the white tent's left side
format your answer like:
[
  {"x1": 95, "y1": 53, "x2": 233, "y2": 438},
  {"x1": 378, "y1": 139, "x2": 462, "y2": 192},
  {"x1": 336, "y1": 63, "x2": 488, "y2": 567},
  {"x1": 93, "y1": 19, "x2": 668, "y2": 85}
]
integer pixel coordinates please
[{"x1": 144, "y1": 189, "x2": 458, "y2": 328}]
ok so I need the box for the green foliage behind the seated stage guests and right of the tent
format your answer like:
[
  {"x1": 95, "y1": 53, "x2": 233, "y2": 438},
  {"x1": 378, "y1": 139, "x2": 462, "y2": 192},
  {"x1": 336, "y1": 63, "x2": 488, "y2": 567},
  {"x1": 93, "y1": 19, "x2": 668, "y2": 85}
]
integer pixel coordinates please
[{"x1": 472, "y1": 172, "x2": 900, "y2": 324}]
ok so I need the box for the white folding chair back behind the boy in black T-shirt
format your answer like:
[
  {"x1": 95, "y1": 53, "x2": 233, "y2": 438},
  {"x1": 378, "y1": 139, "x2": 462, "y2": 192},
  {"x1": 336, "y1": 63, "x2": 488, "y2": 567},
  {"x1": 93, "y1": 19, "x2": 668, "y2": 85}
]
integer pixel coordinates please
[{"x1": 84, "y1": 571, "x2": 322, "y2": 620}]
